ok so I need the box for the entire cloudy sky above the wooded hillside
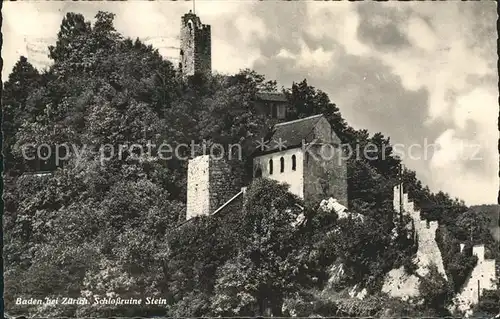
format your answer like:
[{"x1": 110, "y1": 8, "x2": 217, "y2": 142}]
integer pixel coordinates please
[{"x1": 2, "y1": 0, "x2": 499, "y2": 205}]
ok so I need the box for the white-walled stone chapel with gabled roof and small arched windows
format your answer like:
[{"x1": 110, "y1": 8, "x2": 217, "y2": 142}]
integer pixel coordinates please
[{"x1": 253, "y1": 115, "x2": 347, "y2": 206}]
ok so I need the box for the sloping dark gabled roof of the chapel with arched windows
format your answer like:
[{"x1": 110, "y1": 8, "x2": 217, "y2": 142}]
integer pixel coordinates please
[{"x1": 256, "y1": 114, "x2": 324, "y2": 153}]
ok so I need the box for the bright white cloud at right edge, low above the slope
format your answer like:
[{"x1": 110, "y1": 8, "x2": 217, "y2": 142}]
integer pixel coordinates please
[{"x1": 431, "y1": 87, "x2": 498, "y2": 203}]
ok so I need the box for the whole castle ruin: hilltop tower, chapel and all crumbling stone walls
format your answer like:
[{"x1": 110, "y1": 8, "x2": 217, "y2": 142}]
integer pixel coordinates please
[{"x1": 179, "y1": 11, "x2": 497, "y2": 315}]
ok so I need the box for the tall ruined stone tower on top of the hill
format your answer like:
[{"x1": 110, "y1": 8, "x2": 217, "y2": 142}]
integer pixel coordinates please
[{"x1": 179, "y1": 10, "x2": 212, "y2": 77}]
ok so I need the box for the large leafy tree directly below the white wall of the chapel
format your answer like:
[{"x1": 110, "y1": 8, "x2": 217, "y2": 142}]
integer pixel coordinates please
[{"x1": 210, "y1": 179, "x2": 306, "y2": 315}]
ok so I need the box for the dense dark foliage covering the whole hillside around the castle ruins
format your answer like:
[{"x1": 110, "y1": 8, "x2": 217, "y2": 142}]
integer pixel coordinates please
[{"x1": 2, "y1": 12, "x2": 494, "y2": 317}]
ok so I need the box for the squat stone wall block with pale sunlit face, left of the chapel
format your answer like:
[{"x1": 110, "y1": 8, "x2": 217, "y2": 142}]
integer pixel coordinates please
[{"x1": 186, "y1": 155, "x2": 242, "y2": 219}]
